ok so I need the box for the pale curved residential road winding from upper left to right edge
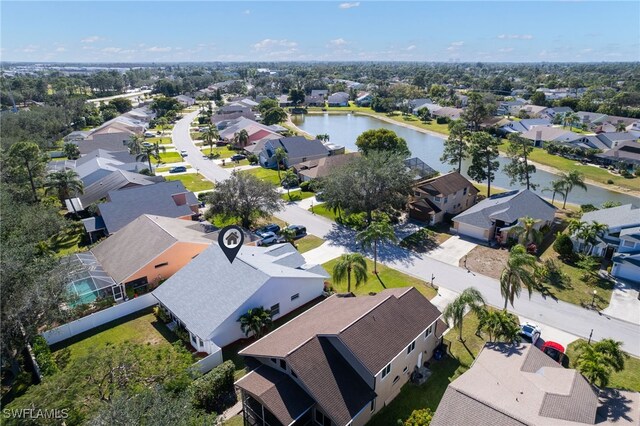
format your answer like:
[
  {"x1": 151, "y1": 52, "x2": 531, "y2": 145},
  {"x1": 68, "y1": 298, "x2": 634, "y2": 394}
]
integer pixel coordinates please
[{"x1": 173, "y1": 111, "x2": 640, "y2": 356}]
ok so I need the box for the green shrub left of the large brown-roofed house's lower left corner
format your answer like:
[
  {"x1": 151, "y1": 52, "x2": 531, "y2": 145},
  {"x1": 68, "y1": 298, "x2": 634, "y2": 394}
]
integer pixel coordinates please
[{"x1": 189, "y1": 361, "x2": 236, "y2": 413}]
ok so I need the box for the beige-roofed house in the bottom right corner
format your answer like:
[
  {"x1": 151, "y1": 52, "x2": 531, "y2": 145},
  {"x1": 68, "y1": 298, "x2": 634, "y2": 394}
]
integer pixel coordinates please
[{"x1": 431, "y1": 343, "x2": 640, "y2": 426}]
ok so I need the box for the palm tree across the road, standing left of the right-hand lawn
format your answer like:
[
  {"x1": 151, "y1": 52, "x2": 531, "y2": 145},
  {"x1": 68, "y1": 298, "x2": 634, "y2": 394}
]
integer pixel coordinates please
[{"x1": 500, "y1": 244, "x2": 536, "y2": 311}]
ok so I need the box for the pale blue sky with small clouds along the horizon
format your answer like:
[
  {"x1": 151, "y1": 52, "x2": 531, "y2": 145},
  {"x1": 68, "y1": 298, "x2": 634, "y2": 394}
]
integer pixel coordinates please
[{"x1": 0, "y1": 0, "x2": 640, "y2": 62}]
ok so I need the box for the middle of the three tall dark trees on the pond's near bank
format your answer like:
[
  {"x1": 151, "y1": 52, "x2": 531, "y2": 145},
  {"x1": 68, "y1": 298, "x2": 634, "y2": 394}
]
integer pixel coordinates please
[{"x1": 467, "y1": 132, "x2": 500, "y2": 197}]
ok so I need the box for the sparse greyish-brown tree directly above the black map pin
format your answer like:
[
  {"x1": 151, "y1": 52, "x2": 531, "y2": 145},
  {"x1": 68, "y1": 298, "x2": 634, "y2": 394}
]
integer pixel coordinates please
[{"x1": 205, "y1": 171, "x2": 283, "y2": 229}]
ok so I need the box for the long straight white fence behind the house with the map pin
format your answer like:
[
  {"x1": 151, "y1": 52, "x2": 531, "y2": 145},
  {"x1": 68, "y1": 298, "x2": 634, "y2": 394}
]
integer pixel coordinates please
[{"x1": 42, "y1": 293, "x2": 158, "y2": 346}]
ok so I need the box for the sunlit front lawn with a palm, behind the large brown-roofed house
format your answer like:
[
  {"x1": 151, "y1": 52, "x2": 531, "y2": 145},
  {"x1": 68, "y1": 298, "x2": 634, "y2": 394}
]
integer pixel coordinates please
[{"x1": 322, "y1": 259, "x2": 438, "y2": 299}]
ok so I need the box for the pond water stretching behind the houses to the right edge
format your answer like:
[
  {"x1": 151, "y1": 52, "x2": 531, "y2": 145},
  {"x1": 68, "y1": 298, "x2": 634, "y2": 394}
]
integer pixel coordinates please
[{"x1": 292, "y1": 114, "x2": 640, "y2": 206}]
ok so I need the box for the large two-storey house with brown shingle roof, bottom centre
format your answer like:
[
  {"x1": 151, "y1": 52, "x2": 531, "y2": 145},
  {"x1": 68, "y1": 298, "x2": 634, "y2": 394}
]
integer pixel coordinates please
[{"x1": 236, "y1": 287, "x2": 447, "y2": 426}]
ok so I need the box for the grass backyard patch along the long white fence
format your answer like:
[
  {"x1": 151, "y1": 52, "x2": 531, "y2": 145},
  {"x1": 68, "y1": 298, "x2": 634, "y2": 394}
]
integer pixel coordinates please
[{"x1": 51, "y1": 308, "x2": 178, "y2": 360}]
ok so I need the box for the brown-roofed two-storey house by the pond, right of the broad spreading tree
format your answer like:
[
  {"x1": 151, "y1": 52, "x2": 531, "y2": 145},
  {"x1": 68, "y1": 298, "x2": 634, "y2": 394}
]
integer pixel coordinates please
[{"x1": 409, "y1": 172, "x2": 478, "y2": 225}]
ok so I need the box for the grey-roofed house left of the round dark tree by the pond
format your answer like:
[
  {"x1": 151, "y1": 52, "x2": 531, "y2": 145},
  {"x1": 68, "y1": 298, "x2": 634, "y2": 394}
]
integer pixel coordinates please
[{"x1": 258, "y1": 136, "x2": 329, "y2": 168}]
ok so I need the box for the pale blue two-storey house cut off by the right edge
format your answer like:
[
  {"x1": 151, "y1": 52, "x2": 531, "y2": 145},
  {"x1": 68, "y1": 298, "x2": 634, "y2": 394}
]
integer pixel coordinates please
[{"x1": 572, "y1": 204, "x2": 640, "y2": 281}]
